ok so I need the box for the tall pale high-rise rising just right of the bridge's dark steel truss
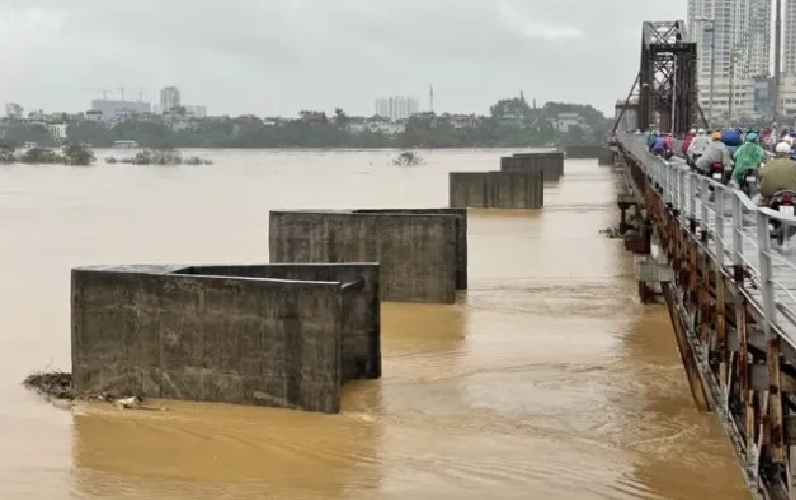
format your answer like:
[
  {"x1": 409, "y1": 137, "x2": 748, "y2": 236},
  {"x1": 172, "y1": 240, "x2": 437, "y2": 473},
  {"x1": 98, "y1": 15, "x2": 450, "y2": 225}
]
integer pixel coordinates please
[{"x1": 688, "y1": 0, "x2": 768, "y2": 122}]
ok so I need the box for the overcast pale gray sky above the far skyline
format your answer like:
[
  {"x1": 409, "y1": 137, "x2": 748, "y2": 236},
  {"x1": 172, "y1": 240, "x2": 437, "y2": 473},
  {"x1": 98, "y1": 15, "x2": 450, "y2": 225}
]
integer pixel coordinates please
[{"x1": 0, "y1": 0, "x2": 686, "y2": 116}]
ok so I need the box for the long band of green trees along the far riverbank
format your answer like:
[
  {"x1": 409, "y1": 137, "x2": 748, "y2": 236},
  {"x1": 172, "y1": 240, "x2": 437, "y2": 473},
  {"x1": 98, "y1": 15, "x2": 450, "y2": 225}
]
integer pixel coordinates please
[{"x1": 5, "y1": 99, "x2": 611, "y2": 149}]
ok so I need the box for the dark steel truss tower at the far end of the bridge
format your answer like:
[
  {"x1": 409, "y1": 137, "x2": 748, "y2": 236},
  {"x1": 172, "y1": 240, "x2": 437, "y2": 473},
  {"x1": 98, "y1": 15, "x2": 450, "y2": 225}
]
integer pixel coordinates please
[{"x1": 638, "y1": 21, "x2": 699, "y2": 134}]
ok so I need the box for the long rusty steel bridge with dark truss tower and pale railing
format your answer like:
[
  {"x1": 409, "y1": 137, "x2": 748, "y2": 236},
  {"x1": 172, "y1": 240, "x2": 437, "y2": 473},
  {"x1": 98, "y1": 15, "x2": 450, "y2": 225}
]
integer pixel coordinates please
[{"x1": 617, "y1": 21, "x2": 796, "y2": 499}]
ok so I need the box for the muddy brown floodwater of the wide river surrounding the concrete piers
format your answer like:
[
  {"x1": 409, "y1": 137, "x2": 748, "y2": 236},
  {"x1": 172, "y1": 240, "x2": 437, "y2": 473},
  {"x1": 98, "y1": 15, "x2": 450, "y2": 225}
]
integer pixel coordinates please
[{"x1": 0, "y1": 150, "x2": 749, "y2": 500}]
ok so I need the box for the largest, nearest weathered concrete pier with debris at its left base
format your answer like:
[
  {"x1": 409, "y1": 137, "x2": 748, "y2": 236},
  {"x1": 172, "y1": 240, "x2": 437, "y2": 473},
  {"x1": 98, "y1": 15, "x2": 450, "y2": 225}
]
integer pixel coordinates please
[{"x1": 72, "y1": 264, "x2": 381, "y2": 413}]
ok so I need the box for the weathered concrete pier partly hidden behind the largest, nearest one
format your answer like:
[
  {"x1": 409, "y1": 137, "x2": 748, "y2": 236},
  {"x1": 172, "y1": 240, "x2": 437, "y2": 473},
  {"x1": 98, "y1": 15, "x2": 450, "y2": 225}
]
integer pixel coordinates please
[{"x1": 268, "y1": 210, "x2": 466, "y2": 304}]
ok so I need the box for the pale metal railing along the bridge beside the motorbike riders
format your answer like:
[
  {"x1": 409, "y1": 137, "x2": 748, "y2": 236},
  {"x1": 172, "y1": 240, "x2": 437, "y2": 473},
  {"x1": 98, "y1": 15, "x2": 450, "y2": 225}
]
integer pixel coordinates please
[{"x1": 620, "y1": 134, "x2": 796, "y2": 348}]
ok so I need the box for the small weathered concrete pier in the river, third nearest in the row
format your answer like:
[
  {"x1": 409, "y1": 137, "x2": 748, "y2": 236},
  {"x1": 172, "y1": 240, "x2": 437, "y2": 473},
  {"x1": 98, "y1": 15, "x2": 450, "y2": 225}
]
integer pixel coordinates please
[{"x1": 448, "y1": 169, "x2": 544, "y2": 209}]
